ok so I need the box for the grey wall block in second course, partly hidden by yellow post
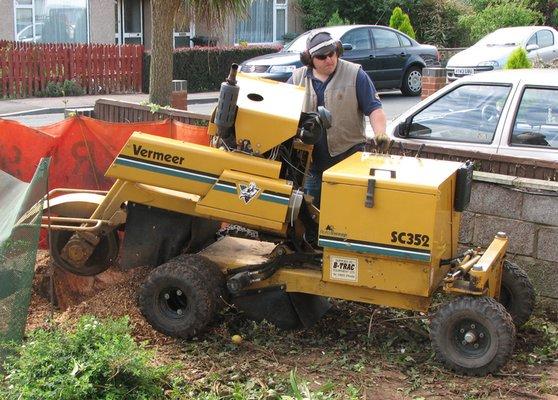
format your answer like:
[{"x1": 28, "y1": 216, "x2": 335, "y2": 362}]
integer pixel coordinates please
[{"x1": 473, "y1": 215, "x2": 537, "y2": 256}]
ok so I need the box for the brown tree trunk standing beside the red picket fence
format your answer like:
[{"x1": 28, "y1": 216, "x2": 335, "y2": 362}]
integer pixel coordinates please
[{"x1": 149, "y1": 0, "x2": 181, "y2": 106}]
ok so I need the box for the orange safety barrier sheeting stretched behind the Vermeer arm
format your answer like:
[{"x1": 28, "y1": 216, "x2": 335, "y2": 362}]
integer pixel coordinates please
[{"x1": 0, "y1": 116, "x2": 209, "y2": 190}]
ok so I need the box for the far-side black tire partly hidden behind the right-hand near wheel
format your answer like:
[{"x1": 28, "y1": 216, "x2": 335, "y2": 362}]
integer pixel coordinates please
[{"x1": 500, "y1": 260, "x2": 536, "y2": 327}]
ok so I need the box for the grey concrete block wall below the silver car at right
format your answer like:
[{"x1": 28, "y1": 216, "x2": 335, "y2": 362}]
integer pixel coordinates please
[{"x1": 459, "y1": 172, "x2": 558, "y2": 306}]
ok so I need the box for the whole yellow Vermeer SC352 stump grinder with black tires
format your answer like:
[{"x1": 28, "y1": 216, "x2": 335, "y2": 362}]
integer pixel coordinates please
[{"x1": 22, "y1": 65, "x2": 534, "y2": 375}]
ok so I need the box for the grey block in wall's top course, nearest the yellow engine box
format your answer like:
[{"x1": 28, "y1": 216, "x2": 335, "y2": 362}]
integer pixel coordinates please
[{"x1": 467, "y1": 182, "x2": 523, "y2": 219}]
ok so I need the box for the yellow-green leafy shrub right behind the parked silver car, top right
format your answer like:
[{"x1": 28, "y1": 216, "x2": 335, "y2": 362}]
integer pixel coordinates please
[{"x1": 459, "y1": 0, "x2": 542, "y2": 45}]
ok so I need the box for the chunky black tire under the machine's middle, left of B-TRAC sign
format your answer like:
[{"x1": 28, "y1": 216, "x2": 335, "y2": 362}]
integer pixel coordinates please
[{"x1": 138, "y1": 255, "x2": 224, "y2": 338}]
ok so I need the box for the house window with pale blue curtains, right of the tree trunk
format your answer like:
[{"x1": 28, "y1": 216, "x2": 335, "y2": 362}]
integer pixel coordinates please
[{"x1": 235, "y1": 0, "x2": 288, "y2": 43}]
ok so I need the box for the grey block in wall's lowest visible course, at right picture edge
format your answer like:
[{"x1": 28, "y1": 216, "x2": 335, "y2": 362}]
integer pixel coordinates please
[{"x1": 508, "y1": 256, "x2": 558, "y2": 299}]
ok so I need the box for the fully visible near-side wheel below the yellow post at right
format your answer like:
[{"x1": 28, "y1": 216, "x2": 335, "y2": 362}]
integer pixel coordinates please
[{"x1": 430, "y1": 296, "x2": 515, "y2": 376}]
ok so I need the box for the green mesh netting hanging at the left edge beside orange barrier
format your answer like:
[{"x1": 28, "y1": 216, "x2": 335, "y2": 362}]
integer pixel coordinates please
[{"x1": 0, "y1": 158, "x2": 50, "y2": 360}]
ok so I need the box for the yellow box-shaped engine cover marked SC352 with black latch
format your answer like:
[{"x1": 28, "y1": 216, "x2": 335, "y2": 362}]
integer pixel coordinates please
[{"x1": 319, "y1": 153, "x2": 462, "y2": 296}]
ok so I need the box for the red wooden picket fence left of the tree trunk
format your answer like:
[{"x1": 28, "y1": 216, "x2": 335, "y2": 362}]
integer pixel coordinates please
[{"x1": 0, "y1": 41, "x2": 143, "y2": 98}]
